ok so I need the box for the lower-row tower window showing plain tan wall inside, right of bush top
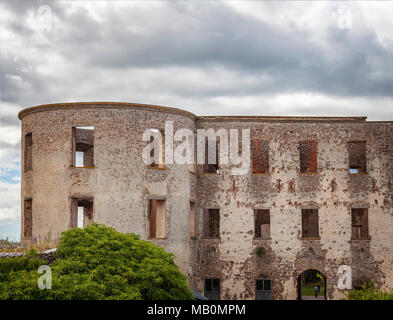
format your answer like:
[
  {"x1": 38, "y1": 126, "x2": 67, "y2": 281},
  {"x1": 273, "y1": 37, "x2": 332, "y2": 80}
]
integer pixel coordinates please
[{"x1": 149, "y1": 199, "x2": 166, "y2": 239}]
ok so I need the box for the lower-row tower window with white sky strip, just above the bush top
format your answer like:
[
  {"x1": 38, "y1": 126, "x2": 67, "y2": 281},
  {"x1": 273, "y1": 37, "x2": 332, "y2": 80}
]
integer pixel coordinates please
[{"x1": 70, "y1": 198, "x2": 93, "y2": 228}]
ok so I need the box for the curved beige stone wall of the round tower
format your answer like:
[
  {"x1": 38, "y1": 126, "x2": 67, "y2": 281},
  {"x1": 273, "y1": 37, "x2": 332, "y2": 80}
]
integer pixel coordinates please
[{"x1": 18, "y1": 104, "x2": 195, "y2": 275}]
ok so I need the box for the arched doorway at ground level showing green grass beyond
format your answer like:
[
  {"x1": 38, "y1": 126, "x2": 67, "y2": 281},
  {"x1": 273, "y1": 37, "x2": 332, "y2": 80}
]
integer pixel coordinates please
[{"x1": 297, "y1": 269, "x2": 326, "y2": 300}]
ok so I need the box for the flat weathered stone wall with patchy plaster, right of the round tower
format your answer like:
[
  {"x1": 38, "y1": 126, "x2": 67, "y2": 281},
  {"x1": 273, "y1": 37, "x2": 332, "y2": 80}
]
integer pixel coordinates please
[{"x1": 196, "y1": 118, "x2": 393, "y2": 299}]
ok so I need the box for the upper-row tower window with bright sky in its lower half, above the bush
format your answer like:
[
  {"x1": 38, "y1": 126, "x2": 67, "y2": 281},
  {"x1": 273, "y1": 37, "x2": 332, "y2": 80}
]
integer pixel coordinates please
[{"x1": 72, "y1": 127, "x2": 94, "y2": 167}]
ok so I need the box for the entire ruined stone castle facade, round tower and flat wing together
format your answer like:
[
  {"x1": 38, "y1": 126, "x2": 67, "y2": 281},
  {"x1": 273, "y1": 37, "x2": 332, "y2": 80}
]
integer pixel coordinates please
[{"x1": 19, "y1": 103, "x2": 393, "y2": 299}]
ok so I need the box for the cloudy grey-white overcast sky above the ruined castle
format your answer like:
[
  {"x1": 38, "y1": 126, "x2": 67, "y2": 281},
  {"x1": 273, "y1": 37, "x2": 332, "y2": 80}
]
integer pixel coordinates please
[{"x1": 0, "y1": 0, "x2": 393, "y2": 238}]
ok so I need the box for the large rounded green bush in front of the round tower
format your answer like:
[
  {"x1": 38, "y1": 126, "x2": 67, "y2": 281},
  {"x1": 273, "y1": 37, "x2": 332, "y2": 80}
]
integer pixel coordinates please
[{"x1": 0, "y1": 224, "x2": 193, "y2": 300}]
